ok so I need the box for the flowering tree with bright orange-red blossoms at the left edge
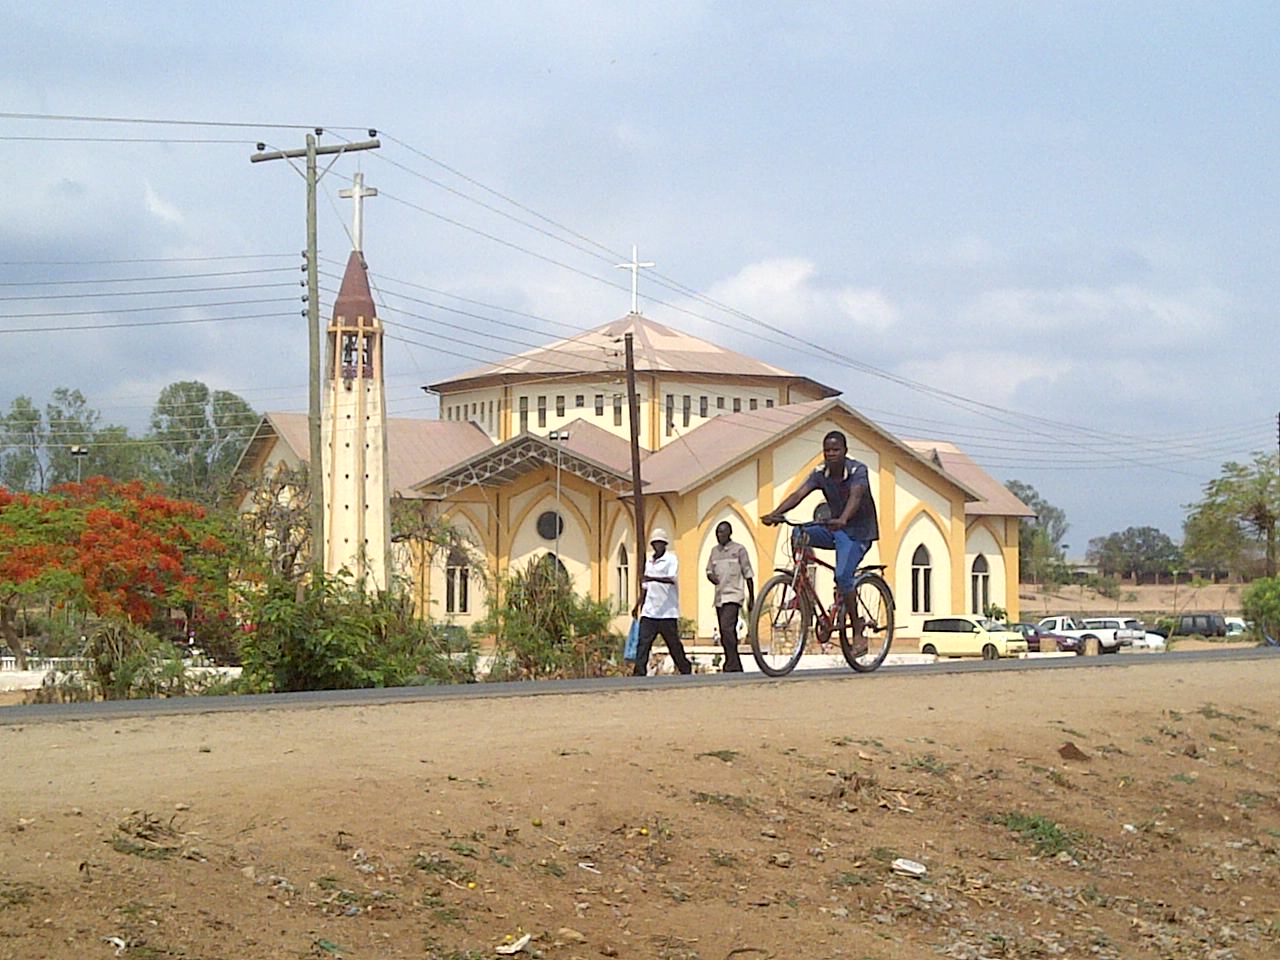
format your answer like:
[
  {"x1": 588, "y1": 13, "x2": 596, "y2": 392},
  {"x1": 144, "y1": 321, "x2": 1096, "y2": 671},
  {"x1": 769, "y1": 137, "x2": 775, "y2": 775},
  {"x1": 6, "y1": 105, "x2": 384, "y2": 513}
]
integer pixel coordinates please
[{"x1": 0, "y1": 477, "x2": 230, "y2": 658}]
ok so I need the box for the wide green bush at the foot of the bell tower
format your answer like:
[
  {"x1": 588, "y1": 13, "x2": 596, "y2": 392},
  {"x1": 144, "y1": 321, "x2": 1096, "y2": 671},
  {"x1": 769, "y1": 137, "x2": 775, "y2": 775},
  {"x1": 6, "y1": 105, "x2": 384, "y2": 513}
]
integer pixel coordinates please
[{"x1": 239, "y1": 577, "x2": 476, "y2": 692}]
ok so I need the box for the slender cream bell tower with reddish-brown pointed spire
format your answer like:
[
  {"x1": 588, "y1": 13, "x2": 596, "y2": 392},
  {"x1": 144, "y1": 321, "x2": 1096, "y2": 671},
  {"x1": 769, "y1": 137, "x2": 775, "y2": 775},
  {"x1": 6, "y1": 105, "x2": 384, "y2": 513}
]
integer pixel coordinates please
[{"x1": 323, "y1": 248, "x2": 390, "y2": 590}]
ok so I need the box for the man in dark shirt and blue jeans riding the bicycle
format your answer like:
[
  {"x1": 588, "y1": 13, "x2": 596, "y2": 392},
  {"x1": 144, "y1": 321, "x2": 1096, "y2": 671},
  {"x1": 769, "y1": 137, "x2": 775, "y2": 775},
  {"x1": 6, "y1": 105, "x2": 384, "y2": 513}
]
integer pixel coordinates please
[{"x1": 760, "y1": 430, "x2": 879, "y2": 649}]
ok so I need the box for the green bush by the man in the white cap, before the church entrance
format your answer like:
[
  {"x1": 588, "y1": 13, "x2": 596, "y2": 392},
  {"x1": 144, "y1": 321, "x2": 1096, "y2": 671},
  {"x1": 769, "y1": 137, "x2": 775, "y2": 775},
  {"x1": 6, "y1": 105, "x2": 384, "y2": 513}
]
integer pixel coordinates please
[{"x1": 481, "y1": 554, "x2": 622, "y2": 680}]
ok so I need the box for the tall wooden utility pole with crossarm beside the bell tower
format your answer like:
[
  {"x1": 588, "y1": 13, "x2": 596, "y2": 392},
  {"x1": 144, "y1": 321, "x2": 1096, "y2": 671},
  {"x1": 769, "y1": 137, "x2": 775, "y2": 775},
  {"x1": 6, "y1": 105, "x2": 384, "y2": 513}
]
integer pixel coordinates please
[{"x1": 250, "y1": 127, "x2": 381, "y2": 573}]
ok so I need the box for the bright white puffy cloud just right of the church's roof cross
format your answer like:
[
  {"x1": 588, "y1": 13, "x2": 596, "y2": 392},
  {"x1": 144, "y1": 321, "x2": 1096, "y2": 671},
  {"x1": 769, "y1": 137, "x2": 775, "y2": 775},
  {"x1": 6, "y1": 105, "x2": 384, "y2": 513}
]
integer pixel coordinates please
[{"x1": 708, "y1": 257, "x2": 899, "y2": 334}]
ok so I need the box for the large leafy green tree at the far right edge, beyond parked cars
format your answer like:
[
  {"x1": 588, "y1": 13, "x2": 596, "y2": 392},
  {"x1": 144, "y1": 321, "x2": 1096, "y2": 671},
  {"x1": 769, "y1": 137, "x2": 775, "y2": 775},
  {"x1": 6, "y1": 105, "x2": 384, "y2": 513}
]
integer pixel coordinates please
[{"x1": 1183, "y1": 453, "x2": 1280, "y2": 577}]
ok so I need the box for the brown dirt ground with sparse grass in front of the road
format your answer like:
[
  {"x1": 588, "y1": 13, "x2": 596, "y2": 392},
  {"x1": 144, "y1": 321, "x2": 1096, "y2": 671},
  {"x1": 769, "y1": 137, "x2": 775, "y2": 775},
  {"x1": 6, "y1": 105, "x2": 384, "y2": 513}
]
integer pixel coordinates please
[{"x1": 0, "y1": 655, "x2": 1280, "y2": 960}]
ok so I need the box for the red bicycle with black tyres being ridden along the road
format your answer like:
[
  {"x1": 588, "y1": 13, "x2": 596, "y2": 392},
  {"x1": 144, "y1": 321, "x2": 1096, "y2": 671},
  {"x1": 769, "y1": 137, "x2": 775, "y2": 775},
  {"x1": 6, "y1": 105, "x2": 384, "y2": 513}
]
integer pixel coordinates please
[{"x1": 750, "y1": 520, "x2": 893, "y2": 677}]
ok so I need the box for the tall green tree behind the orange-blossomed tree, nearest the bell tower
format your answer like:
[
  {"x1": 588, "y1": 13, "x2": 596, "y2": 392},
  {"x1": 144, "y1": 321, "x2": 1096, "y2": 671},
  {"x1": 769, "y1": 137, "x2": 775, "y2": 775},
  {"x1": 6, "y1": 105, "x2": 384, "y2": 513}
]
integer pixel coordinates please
[{"x1": 151, "y1": 380, "x2": 259, "y2": 503}]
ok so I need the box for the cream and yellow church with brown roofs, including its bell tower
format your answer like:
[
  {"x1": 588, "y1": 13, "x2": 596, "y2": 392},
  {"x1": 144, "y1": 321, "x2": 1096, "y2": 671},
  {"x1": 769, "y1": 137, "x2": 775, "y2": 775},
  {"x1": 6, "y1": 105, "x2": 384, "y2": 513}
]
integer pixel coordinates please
[{"x1": 238, "y1": 300, "x2": 1032, "y2": 644}]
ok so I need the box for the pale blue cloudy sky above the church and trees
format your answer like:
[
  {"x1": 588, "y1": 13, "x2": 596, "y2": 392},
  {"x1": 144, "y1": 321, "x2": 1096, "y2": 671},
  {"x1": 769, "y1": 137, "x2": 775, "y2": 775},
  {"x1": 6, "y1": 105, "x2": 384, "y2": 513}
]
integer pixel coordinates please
[{"x1": 0, "y1": 0, "x2": 1280, "y2": 558}]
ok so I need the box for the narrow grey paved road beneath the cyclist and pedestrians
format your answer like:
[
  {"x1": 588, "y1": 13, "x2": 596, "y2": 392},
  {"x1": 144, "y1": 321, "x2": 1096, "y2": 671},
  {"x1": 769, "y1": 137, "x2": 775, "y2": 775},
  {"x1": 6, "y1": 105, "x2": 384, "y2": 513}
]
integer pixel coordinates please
[{"x1": 0, "y1": 646, "x2": 1280, "y2": 726}]
